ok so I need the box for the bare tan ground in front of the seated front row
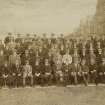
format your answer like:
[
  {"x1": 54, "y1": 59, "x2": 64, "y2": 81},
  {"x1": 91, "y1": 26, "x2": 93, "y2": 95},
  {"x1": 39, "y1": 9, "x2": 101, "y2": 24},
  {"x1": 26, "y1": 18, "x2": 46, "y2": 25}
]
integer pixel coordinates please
[{"x1": 0, "y1": 86, "x2": 105, "y2": 105}]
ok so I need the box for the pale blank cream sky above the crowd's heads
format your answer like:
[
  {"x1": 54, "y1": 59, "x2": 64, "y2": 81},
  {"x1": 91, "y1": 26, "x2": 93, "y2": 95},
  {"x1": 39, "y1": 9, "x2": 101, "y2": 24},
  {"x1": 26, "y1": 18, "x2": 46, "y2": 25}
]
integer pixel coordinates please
[{"x1": 0, "y1": 0, "x2": 97, "y2": 35}]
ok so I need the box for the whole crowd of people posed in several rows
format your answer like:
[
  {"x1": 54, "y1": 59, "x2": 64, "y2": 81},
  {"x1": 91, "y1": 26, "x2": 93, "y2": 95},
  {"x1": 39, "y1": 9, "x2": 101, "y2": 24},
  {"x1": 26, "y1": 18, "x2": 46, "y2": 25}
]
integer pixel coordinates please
[{"x1": 0, "y1": 33, "x2": 105, "y2": 87}]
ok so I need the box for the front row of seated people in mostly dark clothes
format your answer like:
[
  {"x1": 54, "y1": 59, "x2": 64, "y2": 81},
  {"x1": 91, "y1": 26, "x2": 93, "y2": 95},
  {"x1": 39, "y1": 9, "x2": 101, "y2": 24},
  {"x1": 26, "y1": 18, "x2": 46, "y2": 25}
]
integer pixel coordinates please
[{"x1": 0, "y1": 59, "x2": 105, "y2": 88}]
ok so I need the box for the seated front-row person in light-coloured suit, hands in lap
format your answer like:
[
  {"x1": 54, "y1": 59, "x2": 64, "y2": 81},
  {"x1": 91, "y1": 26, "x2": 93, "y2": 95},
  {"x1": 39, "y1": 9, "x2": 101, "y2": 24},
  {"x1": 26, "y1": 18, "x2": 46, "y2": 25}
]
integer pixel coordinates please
[{"x1": 23, "y1": 61, "x2": 33, "y2": 86}]
